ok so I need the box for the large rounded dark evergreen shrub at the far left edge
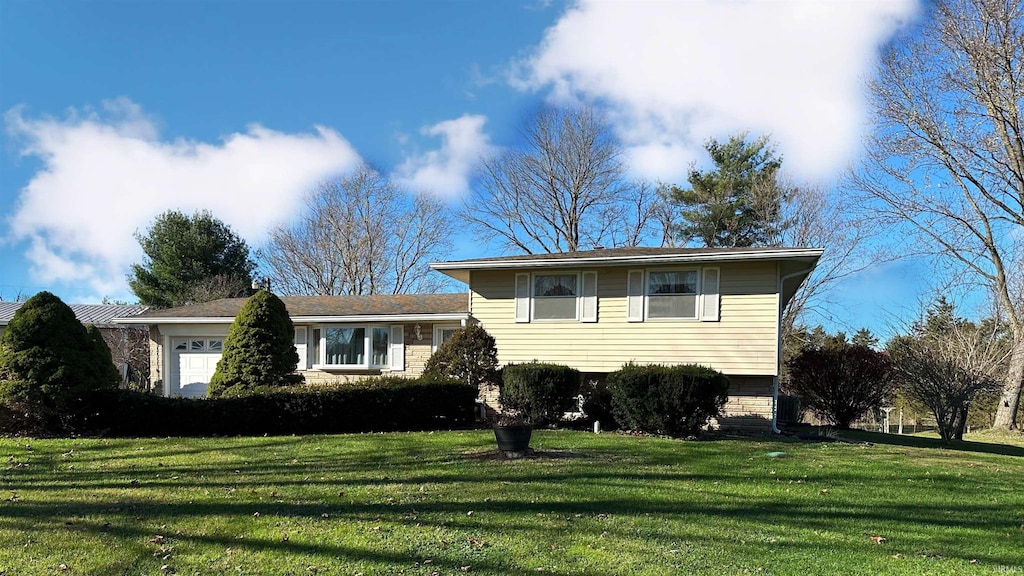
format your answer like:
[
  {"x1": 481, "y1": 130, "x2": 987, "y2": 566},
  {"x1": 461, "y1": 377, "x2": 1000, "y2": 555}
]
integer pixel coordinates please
[{"x1": 0, "y1": 292, "x2": 120, "y2": 415}]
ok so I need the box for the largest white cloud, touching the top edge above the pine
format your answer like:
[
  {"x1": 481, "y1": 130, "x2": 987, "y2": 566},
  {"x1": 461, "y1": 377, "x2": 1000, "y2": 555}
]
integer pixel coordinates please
[{"x1": 511, "y1": 0, "x2": 918, "y2": 179}]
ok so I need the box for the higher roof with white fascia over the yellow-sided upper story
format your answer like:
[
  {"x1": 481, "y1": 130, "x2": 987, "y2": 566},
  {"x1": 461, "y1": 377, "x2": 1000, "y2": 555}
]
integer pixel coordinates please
[{"x1": 430, "y1": 247, "x2": 822, "y2": 283}]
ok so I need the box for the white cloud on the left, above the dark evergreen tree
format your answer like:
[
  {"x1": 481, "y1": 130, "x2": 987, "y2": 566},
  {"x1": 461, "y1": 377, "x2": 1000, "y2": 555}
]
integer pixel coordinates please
[{"x1": 5, "y1": 98, "x2": 358, "y2": 295}]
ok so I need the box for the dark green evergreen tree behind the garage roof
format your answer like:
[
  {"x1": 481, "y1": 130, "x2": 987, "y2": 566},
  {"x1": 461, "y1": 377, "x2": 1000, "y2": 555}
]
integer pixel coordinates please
[{"x1": 128, "y1": 210, "x2": 256, "y2": 307}]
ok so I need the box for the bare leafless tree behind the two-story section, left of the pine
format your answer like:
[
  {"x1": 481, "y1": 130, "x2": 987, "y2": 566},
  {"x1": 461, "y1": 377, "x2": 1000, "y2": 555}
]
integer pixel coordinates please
[{"x1": 462, "y1": 109, "x2": 657, "y2": 254}]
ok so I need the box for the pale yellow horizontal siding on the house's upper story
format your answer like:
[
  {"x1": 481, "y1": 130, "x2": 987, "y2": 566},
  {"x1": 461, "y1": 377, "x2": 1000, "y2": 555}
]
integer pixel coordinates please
[{"x1": 470, "y1": 262, "x2": 777, "y2": 375}]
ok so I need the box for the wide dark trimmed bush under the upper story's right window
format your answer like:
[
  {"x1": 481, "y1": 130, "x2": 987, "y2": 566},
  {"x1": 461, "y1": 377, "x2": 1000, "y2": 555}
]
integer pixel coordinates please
[{"x1": 607, "y1": 363, "x2": 729, "y2": 437}]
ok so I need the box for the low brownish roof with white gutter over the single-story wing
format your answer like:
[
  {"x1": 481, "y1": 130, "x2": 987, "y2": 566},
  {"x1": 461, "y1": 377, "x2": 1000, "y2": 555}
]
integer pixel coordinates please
[{"x1": 118, "y1": 292, "x2": 469, "y2": 324}]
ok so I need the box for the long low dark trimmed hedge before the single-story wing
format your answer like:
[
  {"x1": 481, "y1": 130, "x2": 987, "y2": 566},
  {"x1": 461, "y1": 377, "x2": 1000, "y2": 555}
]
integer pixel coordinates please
[{"x1": 0, "y1": 377, "x2": 477, "y2": 437}]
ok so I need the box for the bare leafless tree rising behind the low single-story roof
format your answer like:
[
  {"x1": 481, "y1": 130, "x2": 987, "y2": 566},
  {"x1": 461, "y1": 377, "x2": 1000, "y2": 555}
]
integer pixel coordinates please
[{"x1": 259, "y1": 165, "x2": 453, "y2": 295}]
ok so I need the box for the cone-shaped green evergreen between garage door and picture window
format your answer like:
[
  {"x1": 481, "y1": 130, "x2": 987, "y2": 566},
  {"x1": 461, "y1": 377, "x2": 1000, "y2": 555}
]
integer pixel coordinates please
[{"x1": 207, "y1": 290, "x2": 303, "y2": 396}]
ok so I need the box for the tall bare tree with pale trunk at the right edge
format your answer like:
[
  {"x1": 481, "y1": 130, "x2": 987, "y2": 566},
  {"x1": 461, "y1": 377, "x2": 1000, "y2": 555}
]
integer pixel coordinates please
[{"x1": 851, "y1": 0, "x2": 1024, "y2": 428}]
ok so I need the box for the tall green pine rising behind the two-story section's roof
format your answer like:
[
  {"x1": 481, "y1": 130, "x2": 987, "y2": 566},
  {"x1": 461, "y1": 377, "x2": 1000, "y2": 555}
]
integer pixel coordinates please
[{"x1": 670, "y1": 133, "x2": 784, "y2": 248}]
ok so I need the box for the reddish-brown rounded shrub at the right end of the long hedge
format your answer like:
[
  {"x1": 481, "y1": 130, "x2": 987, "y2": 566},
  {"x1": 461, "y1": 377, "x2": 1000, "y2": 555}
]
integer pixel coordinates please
[{"x1": 424, "y1": 324, "x2": 498, "y2": 386}]
